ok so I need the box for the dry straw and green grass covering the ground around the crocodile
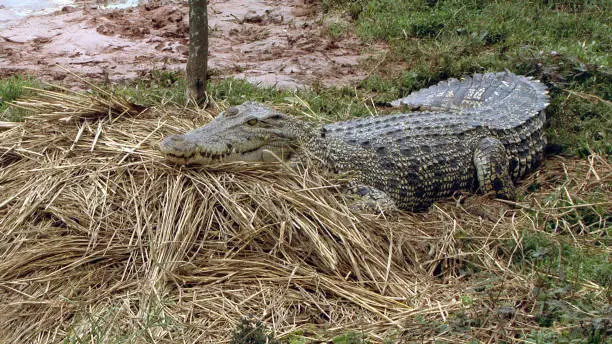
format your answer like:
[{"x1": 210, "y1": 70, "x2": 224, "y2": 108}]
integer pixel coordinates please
[{"x1": 0, "y1": 0, "x2": 612, "y2": 343}]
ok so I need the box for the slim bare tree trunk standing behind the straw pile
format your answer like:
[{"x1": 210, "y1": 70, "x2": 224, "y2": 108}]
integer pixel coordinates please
[{"x1": 187, "y1": 0, "x2": 208, "y2": 103}]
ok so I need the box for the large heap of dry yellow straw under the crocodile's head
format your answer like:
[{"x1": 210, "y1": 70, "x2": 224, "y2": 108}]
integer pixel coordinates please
[{"x1": 0, "y1": 84, "x2": 611, "y2": 343}]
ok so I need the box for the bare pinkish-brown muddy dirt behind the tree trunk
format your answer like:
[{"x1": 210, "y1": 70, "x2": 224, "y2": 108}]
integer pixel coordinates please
[{"x1": 0, "y1": 0, "x2": 382, "y2": 89}]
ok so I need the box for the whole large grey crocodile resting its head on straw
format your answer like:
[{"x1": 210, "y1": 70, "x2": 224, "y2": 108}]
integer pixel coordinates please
[{"x1": 160, "y1": 71, "x2": 549, "y2": 211}]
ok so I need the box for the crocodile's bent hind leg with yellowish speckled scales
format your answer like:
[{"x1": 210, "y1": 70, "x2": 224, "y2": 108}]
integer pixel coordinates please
[{"x1": 474, "y1": 137, "x2": 516, "y2": 200}]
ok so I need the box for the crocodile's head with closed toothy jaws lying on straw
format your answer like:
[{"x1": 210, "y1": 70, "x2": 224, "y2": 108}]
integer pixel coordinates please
[{"x1": 160, "y1": 102, "x2": 310, "y2": 164}]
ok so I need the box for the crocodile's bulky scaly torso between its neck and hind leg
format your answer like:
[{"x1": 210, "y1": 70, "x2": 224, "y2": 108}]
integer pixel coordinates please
[{"x1": 314, "y1": 112, "x2": 488, "y2": 210}]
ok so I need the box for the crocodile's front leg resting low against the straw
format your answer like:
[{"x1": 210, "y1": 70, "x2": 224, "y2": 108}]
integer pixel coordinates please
[{"x1": 347, "y1": 180, "x2": 397, "y2": 213}]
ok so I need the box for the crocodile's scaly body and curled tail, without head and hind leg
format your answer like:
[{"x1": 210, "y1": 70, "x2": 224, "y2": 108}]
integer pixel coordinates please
[{"x1": 307, "y1": 73, "x2": 548, "y2": 210}]
